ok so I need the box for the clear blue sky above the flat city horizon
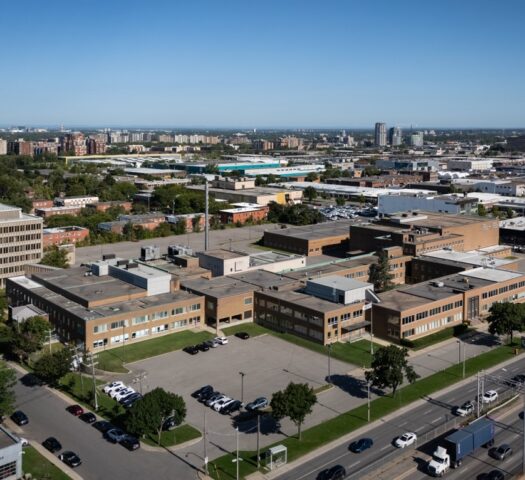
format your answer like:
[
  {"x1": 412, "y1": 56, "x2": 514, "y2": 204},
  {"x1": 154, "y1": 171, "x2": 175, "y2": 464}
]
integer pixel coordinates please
[{"x1": 0, "y1": 0, "x2": 525, "y2": 128}]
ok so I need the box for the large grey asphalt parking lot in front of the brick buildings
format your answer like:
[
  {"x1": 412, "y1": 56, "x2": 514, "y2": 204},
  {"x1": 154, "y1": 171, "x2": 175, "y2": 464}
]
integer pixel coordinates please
[{"x1": 128, "y1": 335, "x2": 356, "y2": 463}]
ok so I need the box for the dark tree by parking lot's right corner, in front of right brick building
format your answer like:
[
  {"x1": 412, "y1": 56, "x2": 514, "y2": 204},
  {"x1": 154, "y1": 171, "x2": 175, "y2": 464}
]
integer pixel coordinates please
[{"x1": 365, "y1": 345, "x2": 419, "y2": 395}]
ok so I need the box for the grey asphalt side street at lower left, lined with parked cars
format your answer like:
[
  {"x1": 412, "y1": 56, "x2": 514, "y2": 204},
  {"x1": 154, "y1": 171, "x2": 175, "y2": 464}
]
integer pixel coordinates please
[{"x1": 15, "y1": 375, "x2": 201, "y2": 480}]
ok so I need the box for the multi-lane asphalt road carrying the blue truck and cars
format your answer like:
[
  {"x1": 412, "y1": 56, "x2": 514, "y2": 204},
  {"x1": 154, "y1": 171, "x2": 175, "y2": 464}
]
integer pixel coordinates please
[{"x1": 276, "y1": 352, "x2": 525, "y2": 480}]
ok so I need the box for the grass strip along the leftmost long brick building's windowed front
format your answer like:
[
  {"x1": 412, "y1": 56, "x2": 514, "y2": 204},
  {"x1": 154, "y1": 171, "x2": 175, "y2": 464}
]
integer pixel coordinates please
[{"x1": 97, "y1": 330, "x2": 213, "y2": 373}]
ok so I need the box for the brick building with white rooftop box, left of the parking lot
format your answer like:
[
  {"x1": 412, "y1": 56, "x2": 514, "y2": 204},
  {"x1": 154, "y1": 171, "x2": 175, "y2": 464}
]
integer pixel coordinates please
[{"x1": 6, "y1": 258, "x2": 204, "y2": 351}]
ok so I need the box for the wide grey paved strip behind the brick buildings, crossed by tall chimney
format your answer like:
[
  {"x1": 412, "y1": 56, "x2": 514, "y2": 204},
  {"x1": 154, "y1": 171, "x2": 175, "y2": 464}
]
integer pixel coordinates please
[{"x1": 75, "y1": 223, "x2": 280, "y2": 266}]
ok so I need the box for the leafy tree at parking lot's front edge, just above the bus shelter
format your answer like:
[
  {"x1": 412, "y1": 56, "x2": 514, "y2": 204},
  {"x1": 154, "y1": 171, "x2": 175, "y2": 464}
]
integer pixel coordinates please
[{"x1": 270, "y1": 382, "x2": 317, "y2": 440}]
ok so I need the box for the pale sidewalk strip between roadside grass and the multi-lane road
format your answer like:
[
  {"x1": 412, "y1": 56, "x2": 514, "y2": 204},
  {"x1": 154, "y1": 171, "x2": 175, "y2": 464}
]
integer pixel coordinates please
[{"x1": 246, "y1": 348, "x2": 523, "y2": 480}]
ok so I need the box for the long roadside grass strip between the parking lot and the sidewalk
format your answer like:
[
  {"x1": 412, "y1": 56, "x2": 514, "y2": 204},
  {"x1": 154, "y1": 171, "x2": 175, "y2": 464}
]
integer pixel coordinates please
[{"x1": 210, "y1": 346, "x2": 514, "y2": 480}]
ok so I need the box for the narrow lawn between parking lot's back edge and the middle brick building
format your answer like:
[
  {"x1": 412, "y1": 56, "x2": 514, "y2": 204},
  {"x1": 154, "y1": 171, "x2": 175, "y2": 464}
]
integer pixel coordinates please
[{"x1": 222, "y1": 323, "x2": 381, "y2": 367}]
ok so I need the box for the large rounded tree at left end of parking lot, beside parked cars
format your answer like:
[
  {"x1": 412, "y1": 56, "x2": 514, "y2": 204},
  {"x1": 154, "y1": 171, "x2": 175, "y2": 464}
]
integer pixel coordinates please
[{"x1": 126, "y1": 387, "x2": 186, "y2": 445}]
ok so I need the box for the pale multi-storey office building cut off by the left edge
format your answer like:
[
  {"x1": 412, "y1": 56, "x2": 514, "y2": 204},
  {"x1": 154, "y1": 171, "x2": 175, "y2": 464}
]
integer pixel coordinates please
[{"x1": 0, "y1": 204, "x2": 43, "y2": 288}]
